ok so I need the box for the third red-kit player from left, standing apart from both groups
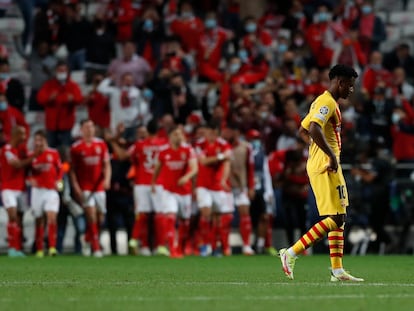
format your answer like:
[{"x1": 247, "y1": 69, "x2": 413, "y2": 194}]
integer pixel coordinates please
[{"x1": 70, "y1": 120, "x2": 112, "y2": 258}]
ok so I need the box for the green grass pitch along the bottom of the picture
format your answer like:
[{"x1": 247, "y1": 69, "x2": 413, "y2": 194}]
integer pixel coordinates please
[{"x1": 0, "y1": 255, "x2": 414, "y2": 311}]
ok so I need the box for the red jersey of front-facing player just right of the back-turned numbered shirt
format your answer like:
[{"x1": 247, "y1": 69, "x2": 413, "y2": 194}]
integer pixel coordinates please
[{"x1": 158, "y1": 144, "x2": 195, "y2": 194}]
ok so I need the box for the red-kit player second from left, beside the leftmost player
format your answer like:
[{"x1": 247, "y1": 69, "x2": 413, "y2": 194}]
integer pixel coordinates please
[{"x1": 30, "y1": 130, "x2": 62, "y2": 258}]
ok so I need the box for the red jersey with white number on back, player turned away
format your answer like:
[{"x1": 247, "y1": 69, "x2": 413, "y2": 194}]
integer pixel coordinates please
[{"x1": 128, "y1": 137, "x2": 167, "y2": 185}]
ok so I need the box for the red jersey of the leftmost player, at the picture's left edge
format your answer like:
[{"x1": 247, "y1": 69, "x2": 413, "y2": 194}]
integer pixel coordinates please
[{"x1": 0, "y1": 144, "x2": 27, "y2": 191}]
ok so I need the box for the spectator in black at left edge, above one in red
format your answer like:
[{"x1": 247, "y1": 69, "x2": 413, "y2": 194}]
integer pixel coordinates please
[{"x1": 0, "y1": 59, "x2": 25, "y2": 111}]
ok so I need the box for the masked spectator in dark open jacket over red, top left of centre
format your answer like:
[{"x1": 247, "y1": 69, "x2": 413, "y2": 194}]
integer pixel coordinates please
[{"x1": 133, "y1": 8, "x2": 164, "y2": 70}]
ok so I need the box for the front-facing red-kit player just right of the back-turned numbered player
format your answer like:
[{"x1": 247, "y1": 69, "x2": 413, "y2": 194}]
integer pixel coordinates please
[{"x1": 152, "y1": 127, "x2": 198, "y2": 258}]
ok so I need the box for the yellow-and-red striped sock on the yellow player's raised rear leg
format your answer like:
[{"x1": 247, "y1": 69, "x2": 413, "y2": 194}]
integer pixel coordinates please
[{"x1": 292, "y1": 217, "x2": 338, "y2": 255}]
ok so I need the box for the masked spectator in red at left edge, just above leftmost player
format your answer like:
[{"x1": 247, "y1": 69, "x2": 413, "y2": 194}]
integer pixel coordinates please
[{"x1": 0, "y1": 85, "x2": 29, "y2": 144}]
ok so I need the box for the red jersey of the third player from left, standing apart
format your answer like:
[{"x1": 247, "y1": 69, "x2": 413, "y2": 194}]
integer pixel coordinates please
[{"x1": 70, "y1": 138, "x2": 109, "y2": 191}]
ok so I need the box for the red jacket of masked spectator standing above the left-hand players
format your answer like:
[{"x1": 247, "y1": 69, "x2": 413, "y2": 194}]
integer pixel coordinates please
[{"x1": 37, "y1": 79, "x2": 83, "y2": 131}]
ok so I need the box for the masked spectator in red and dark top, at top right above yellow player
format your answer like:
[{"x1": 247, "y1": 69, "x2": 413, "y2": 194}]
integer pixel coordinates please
[{"x1": 353, "y1": 0, "x2": 387, "y2": 57}]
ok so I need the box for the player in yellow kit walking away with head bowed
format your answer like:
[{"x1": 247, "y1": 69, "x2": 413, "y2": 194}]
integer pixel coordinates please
[{"x1": 279, "y1": 65, "x2": 363, "y2": 282}]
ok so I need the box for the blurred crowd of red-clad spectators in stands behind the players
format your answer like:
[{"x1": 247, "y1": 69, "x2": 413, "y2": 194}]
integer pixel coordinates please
[{"x1": 0, "y1": 0, "x2": 414, "y2": 253}]
